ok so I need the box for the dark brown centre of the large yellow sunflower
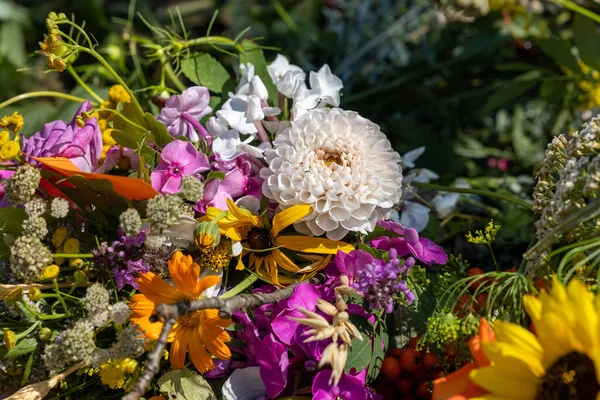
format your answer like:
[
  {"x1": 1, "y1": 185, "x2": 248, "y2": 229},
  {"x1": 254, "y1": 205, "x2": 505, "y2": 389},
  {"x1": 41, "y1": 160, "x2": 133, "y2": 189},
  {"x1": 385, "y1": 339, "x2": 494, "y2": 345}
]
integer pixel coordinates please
[{"x1": 535, "y1": 351, "x2": 600, "y2": 400}]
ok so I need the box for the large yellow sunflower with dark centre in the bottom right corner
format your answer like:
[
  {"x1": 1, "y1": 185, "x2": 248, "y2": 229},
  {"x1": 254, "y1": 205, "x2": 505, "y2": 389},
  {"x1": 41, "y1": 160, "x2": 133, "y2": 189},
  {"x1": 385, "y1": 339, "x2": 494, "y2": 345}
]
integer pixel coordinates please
[{"x1": 470, "y1": 277, "x2": 600, "y2": 400}]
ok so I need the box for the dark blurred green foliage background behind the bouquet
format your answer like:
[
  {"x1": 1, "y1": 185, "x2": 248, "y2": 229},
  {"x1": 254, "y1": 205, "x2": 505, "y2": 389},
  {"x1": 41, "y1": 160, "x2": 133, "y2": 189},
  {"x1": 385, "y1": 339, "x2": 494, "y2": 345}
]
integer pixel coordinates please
[{"x1": 0, "y1": 0, "x2": 600, "y2": 267}]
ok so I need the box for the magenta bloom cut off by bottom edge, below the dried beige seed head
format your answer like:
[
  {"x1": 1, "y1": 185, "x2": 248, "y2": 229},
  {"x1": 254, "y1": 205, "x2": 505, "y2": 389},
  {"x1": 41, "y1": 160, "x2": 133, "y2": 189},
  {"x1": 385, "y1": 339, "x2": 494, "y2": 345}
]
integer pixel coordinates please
[{"x1": 311, "y1": 369, "x2": 369, "y2": 400}]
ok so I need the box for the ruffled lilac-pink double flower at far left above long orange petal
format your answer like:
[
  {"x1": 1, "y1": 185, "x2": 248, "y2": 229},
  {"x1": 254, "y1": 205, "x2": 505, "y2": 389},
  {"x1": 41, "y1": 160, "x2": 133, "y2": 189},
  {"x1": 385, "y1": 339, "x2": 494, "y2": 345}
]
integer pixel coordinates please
[{"x1": 23, "y1": 100, "x2": 102, "y2": 172}]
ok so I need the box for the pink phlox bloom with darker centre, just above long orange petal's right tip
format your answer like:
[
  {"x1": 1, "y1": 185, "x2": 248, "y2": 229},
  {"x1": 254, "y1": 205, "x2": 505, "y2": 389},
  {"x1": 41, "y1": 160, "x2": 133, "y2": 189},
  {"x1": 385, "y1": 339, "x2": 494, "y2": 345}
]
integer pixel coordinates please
[{"x1": 150, "y1": 140, "x2": 209, "y2": 194}]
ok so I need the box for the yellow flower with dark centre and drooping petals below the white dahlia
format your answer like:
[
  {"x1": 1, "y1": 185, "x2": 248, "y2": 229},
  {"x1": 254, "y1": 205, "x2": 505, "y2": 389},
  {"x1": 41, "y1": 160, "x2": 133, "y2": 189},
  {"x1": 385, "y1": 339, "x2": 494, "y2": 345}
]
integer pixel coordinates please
[{"x1": 206, "y1": 199, "x2": 354, "y2": 285}]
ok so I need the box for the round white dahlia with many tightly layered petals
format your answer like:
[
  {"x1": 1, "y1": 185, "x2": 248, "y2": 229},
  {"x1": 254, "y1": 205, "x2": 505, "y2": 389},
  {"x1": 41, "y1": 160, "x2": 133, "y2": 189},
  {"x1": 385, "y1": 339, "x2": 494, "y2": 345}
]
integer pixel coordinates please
[{"x1": 260, "y1": 108, "x2": 402, "y2": 240}]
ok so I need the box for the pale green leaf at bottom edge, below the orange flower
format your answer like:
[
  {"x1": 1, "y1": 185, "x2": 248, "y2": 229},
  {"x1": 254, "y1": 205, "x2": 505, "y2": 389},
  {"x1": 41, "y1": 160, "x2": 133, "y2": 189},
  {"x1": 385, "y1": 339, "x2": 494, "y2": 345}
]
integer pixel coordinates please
[{"x1": 158, "y1": 368, "x2": 217, "y2": 400}]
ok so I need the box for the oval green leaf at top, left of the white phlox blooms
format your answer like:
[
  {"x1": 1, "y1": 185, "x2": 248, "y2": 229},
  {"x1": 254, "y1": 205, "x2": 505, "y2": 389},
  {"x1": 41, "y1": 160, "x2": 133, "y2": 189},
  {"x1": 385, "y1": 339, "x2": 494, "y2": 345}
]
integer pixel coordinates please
[{"x1": 181, "y1": 53, "x2": 234, "y2": 93}]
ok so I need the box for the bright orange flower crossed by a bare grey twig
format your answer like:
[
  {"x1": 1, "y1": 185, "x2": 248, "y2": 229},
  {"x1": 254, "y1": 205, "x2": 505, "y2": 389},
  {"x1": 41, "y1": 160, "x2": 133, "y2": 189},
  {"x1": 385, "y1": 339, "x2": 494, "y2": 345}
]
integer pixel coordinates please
[{"x1": 129, "y1": 251, "x2": 231, "y2": 372}]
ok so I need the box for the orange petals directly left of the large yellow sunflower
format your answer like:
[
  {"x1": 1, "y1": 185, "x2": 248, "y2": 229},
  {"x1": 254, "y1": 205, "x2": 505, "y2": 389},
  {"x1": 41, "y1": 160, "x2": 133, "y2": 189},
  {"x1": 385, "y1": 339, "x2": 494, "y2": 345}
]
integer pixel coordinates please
[{"x1": 431, "y1": 318, "x2": 496, "y2": 400}]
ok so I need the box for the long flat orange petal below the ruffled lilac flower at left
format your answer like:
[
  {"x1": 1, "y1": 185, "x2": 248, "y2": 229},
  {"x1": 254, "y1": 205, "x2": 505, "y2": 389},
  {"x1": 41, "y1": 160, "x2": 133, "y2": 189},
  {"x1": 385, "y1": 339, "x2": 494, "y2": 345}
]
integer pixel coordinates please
[{"x1": 28, "y1": 156, "x2": 158, "y2": 200}]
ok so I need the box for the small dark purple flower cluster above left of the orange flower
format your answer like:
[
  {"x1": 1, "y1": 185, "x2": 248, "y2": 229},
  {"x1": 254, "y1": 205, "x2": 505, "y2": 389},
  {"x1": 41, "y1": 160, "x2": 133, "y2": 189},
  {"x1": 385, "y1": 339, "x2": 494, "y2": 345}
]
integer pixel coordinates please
[{"x1": 92, "y1": 230, "x2": 150, "y2": 290}]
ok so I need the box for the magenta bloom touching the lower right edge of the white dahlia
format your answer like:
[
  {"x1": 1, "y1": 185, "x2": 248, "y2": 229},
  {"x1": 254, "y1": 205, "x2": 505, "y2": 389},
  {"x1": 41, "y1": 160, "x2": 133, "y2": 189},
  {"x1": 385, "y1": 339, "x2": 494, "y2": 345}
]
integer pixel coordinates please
[{"x1": 371, "y1": 221, "x2": 448, "y2": 265}]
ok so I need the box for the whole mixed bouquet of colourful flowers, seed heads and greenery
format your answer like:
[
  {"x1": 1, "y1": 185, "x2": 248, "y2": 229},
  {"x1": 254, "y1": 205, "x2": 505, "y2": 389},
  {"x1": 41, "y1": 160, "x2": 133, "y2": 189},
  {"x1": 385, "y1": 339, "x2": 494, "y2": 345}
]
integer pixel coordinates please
[{"x1": 0, "y1": 7, "x2": 600, "y2": 400}]
